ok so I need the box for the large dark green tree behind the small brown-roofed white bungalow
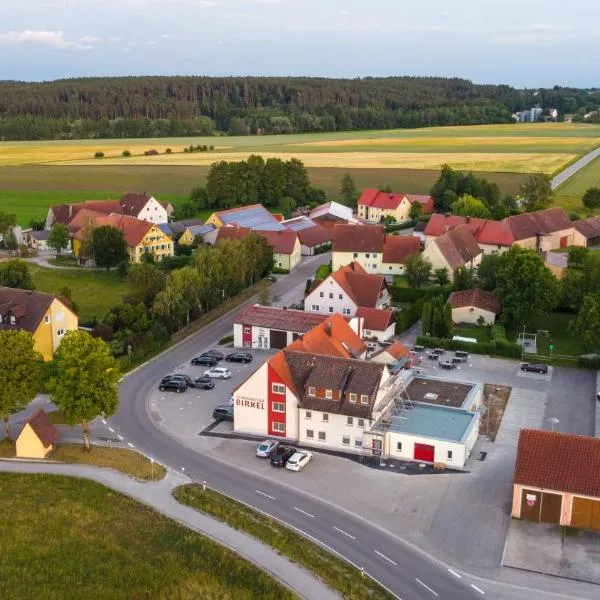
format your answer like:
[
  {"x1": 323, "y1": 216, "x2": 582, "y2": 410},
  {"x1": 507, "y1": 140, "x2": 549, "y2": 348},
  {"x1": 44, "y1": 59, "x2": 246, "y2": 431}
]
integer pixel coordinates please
[{"x1": 495, "y1": 246, "x2": 559, "y2": 326}]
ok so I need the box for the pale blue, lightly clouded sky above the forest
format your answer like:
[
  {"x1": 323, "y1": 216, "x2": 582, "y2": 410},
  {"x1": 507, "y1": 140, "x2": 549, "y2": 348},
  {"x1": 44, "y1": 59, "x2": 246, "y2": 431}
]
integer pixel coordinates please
[{"x1": 0, "y1": 0, "x2": 600, "y2": 88}]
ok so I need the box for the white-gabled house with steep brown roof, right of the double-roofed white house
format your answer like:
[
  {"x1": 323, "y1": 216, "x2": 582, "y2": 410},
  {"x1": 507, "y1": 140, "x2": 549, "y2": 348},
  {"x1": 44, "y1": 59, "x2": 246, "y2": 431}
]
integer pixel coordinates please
[{"x1": 423, "y1": 225, "x2": 483, "y2": 275}]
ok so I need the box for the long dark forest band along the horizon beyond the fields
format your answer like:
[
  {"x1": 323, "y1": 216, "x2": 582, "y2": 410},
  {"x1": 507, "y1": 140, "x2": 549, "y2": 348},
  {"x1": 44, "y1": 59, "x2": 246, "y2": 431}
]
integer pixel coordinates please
[{"x1": 0, "y1": 77, "x2": 600, "y2": 140}]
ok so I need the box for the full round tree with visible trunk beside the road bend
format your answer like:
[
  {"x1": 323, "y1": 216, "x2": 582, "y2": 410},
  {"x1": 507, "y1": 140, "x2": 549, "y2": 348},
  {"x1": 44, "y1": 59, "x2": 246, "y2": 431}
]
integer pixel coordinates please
[{"x1": 48, "y1": 331, "x2": 121, "y2": 450}]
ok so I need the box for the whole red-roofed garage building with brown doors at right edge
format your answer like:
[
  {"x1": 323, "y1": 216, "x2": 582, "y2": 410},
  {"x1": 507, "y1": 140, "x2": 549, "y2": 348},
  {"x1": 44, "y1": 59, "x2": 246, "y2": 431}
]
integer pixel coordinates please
[{"x1": 512, "y1": 429, "x2": 600, "y2": 531}]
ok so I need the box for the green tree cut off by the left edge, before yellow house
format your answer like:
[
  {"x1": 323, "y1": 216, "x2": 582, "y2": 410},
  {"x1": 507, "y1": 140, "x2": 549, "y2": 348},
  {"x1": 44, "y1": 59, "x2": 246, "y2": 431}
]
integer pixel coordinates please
[{"x1": 0, "y1": 329, "x2": 42, "y2": 439}]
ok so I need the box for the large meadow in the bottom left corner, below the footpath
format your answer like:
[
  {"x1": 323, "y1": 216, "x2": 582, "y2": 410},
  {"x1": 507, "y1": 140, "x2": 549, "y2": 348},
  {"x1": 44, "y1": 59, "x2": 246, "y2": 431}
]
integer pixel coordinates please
[{"x1": 0, "y1": 473, "x2": 295, "y2": 600}]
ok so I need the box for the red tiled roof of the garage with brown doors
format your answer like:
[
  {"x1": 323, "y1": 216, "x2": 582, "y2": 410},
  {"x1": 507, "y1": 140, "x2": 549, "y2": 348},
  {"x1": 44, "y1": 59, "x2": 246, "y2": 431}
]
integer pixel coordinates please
[{"x1": 514, "y1": 429, "x2": 600, "y2": 498}]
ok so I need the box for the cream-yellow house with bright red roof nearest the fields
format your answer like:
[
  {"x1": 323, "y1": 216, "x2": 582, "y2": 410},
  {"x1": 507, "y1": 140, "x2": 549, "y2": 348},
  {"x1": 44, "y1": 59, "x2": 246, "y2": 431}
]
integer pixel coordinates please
[{"x1": 358, "y1": 188, "x2": 434, "y2": 223}]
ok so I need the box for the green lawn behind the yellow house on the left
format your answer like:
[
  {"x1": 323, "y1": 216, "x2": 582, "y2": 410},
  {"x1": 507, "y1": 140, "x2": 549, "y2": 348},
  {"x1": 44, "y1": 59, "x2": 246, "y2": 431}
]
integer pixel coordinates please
[{"x1": 30, "y1": 265, "x2": 128, "y2": 324}]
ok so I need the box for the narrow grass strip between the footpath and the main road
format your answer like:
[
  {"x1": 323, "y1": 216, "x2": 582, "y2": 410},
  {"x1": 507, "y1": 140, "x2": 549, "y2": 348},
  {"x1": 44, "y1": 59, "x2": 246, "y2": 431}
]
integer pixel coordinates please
[{"x1": 174, "y1": 484, "x2": 392, "y2": 600}]
